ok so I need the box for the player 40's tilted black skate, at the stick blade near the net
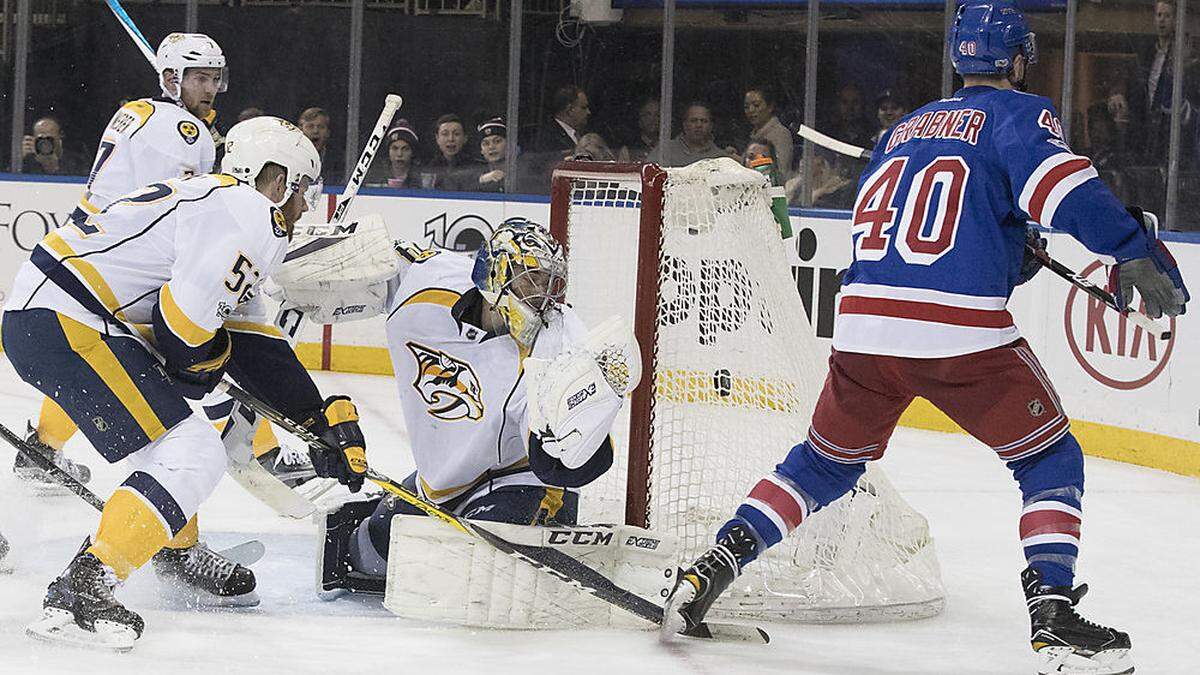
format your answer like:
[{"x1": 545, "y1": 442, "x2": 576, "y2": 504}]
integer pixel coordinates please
[{"x1": 662, "y1": 516, "x2": 758, "y2": 635}]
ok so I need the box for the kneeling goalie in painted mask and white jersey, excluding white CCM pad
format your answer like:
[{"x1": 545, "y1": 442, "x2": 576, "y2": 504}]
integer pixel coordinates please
[{"x1": 276, "y1": 219, "x2": 641, "y2": 592}]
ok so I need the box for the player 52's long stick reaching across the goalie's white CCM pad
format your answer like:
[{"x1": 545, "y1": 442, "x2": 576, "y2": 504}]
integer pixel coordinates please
[{"x1": 217, "y1": 380, "x2": 770, "y2": 643}]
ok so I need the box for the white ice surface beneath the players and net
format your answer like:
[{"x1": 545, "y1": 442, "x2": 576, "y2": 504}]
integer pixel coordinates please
[{"x1": 0, "y1": 359, "x2": 1200, "y2": 675}]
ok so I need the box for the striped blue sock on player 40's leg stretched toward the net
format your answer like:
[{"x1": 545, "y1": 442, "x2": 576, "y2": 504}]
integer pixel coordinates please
[{"x1": 718, "y1": 441, "x2": 865, "y2": 565}]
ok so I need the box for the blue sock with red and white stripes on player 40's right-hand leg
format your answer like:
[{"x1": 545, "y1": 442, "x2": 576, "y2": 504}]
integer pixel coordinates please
[{"x1": 1008, "y1": 434, "x2": 1084, "y2": 586}]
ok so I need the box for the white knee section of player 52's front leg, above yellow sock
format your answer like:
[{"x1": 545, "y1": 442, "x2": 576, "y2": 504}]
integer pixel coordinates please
[{"x1": 130, "y1": 414, "x2": 228, "y2": 518}]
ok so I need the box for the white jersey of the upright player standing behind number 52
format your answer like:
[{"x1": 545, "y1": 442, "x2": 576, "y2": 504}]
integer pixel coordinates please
[{"x1": 79, "y1": 98, "x2": 216, "y2": 219}]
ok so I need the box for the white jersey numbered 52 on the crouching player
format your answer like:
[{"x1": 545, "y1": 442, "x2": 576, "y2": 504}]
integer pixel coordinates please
[{"x1": 5, "y1": 174, "x2": 288, "y2": 346}]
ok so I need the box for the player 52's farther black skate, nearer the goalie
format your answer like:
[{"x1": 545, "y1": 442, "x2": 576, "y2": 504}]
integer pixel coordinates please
[{"x1": 152, "y1": 542, "x2": 258, "y2": 607}]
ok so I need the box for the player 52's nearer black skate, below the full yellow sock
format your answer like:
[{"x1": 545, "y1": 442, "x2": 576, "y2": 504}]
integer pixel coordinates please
[{"x1": 25, "y1": 539, "x2": 145, "y2": 651}]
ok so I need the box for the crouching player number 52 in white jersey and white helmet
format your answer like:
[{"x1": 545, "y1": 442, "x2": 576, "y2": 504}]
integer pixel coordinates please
[{"x1": 2, "y1": 118, "x2": 366, "y2": 650}]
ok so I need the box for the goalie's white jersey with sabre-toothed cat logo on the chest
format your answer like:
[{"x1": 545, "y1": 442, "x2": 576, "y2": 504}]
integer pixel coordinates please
[{"x1": 386, "y1": 243, "x2": 587, "y2": 502}]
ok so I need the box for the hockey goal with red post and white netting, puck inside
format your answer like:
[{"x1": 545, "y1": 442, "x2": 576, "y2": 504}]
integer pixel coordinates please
[{"x1": 551, "y1": 160, "x2": 943, "y2": 622}]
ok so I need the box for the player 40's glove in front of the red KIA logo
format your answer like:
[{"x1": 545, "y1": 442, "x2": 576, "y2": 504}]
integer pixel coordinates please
[{"x1": 1109, "y1": 207, "x2": 1192, "y2": 318}]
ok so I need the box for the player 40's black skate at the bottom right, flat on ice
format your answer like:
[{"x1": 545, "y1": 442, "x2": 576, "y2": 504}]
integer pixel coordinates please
[{"x1": 1021, "y1": 567, "x2": 1133, "y2": 675}]
